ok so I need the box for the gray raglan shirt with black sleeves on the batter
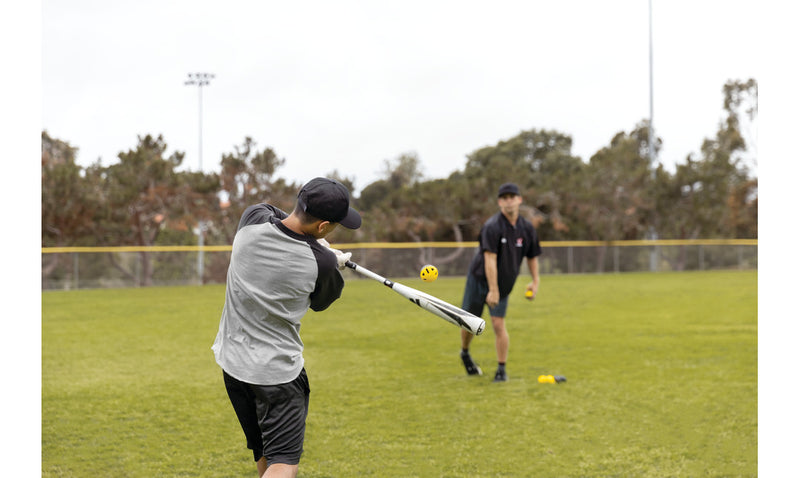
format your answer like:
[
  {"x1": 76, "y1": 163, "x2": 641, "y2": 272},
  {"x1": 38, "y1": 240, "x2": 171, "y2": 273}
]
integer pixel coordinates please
[{"x1": 211, "y1": 204, "x2": 344, "y2": 385}]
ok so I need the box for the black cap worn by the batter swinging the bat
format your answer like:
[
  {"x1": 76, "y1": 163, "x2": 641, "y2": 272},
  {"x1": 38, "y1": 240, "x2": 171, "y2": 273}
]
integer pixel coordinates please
[{"x1": 297, "y1": 178, "x2": 361, "y2": 229}]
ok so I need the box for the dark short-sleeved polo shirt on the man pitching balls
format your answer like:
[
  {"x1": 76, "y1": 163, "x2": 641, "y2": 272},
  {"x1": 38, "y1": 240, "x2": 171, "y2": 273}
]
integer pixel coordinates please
[{"x1": 469, "y1": 212, "x2": 542, "y2": 298}]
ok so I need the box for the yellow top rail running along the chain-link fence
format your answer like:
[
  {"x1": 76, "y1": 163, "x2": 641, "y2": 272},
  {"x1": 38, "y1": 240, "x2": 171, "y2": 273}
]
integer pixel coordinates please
[{"x1": 42, "y1": 239, "x2": 758, "y2": 254}]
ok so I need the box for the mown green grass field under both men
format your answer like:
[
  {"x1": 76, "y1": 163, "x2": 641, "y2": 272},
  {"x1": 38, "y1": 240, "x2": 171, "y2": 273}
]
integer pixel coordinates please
[{"x1": 42, "y1": 271, "x2": 758, "y2": 477}]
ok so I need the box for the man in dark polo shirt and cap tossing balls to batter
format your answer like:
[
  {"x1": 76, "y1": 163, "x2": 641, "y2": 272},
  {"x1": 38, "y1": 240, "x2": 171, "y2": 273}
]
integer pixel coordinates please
[{"x1": 461, "y1": 183, "x2": 542, "y2": 382}]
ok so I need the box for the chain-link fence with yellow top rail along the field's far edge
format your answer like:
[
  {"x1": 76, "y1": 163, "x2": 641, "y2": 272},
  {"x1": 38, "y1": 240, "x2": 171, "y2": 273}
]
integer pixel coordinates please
[{"x1": 42, "y1": 240, "x2": 758, "y2": 290}]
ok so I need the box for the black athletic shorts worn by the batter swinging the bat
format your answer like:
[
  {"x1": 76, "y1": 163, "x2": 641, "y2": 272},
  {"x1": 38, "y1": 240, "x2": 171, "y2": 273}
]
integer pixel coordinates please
[{"x1": 227, "y1": 369, "x2": 311, "y2": 465}]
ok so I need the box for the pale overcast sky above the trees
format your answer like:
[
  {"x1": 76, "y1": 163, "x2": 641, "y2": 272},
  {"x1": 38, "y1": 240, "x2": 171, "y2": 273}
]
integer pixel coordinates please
[{"x1": 42, "y1": 0, "x2": 758, "y2": 190}]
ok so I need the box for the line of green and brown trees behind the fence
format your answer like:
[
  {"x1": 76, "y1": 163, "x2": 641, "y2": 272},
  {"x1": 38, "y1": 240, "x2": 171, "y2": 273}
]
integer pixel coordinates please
[{"x1": 41, "y1": 79, "x2": 758, "y2": 285}]
